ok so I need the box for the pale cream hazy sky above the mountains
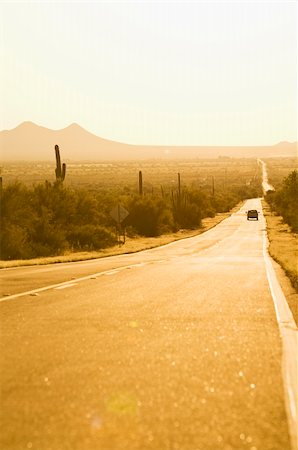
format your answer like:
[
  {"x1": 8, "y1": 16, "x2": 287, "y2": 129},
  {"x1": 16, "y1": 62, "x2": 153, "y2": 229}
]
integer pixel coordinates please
[{"x1": 0, "y1": 0, "x2": 297, "y2": 145}]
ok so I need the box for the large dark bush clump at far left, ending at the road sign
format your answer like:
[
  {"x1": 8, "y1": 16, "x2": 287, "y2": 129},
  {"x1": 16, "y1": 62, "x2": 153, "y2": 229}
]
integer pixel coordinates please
[{"x1": 1, "y1": 183, "x2": 116, "y2": 259}]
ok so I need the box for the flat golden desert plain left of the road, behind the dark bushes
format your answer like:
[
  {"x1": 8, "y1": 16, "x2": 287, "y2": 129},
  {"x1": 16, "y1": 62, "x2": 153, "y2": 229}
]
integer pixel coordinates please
[{"x1": 1, "y1": 158, "x2": 259, "y2": 190}]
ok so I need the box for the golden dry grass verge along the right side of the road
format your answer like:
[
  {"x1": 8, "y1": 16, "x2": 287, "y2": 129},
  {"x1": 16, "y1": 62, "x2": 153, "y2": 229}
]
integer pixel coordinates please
[{"x1": 263, "y1": 201, "x2": 298, "y2": 323}]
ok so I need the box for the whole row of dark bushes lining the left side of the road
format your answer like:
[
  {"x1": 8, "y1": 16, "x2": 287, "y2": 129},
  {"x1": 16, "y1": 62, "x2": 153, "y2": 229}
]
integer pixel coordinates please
[{"x1": 1, "y1": 160, "x2": 261, "y2": 260}]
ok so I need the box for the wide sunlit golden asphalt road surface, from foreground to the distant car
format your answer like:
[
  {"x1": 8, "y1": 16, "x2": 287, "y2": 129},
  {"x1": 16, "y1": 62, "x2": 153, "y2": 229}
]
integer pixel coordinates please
[{"x1": 0, "y1": 199, "x2": 295, "y2": 450}]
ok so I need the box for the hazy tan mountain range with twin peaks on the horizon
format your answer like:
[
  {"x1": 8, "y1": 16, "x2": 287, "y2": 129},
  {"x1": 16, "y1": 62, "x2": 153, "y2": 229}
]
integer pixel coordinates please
[{"x1": 0, "y1": 122, "x2": 297, "y2": 161}]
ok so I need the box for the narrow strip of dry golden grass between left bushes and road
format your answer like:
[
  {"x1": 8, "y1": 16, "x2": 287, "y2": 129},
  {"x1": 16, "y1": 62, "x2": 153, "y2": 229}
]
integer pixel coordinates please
[{"x1": 0, "y1": 208, "x2": 242, "y2": 269}]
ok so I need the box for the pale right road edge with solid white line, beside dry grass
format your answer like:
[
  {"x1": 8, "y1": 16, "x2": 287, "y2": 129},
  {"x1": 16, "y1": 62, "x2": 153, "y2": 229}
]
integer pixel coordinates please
[{"x1": 263, "y1": 214, "x2": 298, "y2": 450}]
